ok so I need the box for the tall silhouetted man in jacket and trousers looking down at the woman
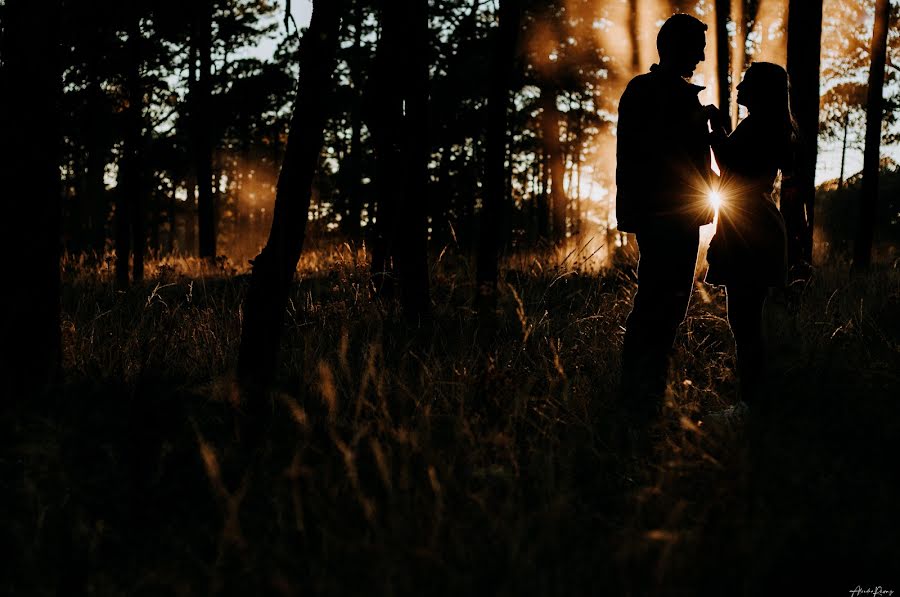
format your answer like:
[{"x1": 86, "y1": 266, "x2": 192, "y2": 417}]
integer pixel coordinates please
[{"x1": 616, "y1": 14, "x2": 712, "y2": 421}]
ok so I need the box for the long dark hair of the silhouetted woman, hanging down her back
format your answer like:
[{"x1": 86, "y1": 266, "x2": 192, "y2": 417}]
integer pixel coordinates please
[{"x1": 747, "y1": 62, "x2": 799, "y2": 173}]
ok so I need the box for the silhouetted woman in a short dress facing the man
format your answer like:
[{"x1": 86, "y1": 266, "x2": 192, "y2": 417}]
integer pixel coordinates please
[{"x1": 706, "y1": 62, "x2": 796, "y2": 407}]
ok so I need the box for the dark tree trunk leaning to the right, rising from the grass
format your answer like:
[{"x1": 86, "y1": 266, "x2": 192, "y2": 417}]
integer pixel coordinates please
[{"x1": 238, "y1": 0, "x2": 343, "y2": 388}]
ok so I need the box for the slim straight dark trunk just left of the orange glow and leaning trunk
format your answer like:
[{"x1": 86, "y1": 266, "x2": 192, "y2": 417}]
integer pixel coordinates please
[{"x1": 190, "y1": 0, "x2": 216, "y2": 260}]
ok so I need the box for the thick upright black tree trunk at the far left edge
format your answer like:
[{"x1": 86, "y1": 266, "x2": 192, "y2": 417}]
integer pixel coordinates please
[{"x1": 0, "y1": 0, "x2": 62, "y2": 402}]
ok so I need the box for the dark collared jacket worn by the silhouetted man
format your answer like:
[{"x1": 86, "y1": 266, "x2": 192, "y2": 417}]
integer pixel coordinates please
[{"x1": 616, "y1": 64, "x2": 713, "y2": 232}]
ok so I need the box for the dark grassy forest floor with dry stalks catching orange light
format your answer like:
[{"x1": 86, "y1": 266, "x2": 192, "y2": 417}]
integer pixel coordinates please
[{"x1": 0, "y1": 248, "x2": 900, "y2": 596}]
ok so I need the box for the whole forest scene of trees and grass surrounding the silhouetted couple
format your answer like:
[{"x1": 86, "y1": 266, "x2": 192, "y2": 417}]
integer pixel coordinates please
[{"x1": 0, "y1": 0, "x2": 900, "y2": 596}]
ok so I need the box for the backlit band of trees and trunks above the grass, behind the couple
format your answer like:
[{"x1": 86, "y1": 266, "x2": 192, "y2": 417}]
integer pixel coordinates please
[{"x1": 0, "y1": 0, "x2": 900, "y2": 394}]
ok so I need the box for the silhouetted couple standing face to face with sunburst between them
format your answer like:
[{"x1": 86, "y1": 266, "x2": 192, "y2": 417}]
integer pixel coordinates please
[{"x1": 616, "y1": 14, "x2": 796, "y2": 428}]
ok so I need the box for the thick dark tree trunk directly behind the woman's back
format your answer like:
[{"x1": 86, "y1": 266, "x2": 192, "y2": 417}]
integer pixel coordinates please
[{"x1": 781, "y1": 0, "x2": 822, "y2": 278}]
